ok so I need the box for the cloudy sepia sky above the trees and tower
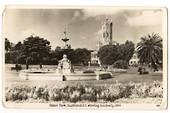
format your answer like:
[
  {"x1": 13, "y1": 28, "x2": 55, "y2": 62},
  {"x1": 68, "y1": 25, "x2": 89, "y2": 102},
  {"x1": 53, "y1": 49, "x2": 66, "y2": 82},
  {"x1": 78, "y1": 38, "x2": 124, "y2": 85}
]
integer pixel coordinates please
[{"x1": 3, "y1": 7, "x2": 163, "y2": 49}]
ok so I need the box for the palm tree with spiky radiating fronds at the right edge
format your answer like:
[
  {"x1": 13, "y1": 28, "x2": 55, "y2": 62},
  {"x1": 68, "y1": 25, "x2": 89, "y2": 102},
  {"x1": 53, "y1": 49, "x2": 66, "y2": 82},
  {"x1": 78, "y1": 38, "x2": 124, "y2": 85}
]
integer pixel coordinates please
[{"x1": 137, "y1": 33, "x2": 162, "y2": 70}]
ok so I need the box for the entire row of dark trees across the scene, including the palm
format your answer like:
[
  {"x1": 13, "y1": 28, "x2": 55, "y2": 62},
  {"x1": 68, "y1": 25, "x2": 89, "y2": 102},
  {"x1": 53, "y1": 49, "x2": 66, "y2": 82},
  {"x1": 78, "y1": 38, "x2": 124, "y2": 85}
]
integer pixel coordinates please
[{"x1": 5, "y1": 33, "x2": 163, "y2": 69}]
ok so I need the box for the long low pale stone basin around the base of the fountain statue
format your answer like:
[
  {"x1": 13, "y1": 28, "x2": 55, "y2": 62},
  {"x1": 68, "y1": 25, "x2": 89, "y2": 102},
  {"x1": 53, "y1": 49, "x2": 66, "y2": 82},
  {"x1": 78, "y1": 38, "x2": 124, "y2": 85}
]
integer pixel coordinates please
[{"x1": 19, "y1": 70, "x2": 112, "y2": 81}]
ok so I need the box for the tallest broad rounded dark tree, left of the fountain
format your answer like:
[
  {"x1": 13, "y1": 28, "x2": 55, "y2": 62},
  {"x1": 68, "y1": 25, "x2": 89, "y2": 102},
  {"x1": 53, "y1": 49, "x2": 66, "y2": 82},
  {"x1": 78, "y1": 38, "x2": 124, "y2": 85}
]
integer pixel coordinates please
[{"x1": 22, "y1": 36, "x2": 51, "y2": 68}]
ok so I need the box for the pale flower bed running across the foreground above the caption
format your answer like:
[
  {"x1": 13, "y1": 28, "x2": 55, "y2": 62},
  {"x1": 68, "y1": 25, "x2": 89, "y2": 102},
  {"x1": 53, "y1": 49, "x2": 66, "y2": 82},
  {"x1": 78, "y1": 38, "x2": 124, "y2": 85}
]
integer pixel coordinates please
[{"x1": 5, "y1": 81, "x2": 163, "y2": 102}]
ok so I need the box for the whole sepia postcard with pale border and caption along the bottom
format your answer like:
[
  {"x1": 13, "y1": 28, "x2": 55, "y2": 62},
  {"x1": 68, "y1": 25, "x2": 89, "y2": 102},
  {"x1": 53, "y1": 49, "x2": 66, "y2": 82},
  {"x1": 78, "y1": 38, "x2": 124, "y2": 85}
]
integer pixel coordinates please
[{"x1": 2, "y1": 5, "x2": 168, "y2": 110}]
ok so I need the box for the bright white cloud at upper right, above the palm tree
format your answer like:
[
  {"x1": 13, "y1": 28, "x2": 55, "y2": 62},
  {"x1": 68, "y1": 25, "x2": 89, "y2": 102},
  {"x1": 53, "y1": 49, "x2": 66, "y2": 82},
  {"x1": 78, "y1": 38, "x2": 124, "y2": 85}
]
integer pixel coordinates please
[{"x1": 127, "y1": 10, "x2": 162, "y2": 26}]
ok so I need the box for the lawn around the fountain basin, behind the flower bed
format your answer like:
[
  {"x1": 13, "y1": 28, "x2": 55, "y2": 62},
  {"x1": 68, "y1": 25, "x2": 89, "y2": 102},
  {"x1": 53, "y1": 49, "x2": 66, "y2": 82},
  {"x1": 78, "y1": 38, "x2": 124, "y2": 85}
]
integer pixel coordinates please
[{"x1": 5, "y1": 65, "x2": 162, "y2": 85}]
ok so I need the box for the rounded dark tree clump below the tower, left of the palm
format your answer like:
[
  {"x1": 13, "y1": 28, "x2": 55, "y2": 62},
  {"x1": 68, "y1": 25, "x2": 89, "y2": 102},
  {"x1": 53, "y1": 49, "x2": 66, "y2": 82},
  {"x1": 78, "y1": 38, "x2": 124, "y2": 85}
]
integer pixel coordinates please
[{"x1": 98, "y1": 41, "x2": 135, "y2": 65}]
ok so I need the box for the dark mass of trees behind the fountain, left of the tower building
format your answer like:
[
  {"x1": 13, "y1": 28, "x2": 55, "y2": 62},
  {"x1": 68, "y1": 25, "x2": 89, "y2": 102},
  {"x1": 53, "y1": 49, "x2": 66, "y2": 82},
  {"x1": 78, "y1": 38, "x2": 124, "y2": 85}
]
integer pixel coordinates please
[{"x1": 5, "y1": 36, "x2": 91, "y2": 65}]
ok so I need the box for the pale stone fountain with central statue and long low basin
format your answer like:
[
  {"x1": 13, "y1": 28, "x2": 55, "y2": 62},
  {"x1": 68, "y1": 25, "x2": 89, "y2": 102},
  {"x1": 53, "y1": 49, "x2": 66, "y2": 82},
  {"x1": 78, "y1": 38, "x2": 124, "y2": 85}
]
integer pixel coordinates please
[{"x1": 19, "y1": 54, "x2": 112, "y2": 81}]
